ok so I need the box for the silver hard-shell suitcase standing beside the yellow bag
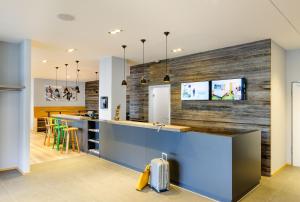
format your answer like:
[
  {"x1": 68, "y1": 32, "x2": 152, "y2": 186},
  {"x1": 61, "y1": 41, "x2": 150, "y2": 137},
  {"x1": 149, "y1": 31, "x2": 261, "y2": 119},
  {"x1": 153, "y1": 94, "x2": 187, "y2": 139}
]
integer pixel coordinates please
[{"x1": 150, "y1": 153, "x2": 170, "y2": 192}]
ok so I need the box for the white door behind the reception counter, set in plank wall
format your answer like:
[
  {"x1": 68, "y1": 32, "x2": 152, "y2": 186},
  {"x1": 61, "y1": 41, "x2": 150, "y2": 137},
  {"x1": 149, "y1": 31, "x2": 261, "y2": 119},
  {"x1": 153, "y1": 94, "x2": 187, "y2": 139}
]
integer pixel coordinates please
[{"x1": 149, "y1": 85, "x2": 171, "y2": 124}]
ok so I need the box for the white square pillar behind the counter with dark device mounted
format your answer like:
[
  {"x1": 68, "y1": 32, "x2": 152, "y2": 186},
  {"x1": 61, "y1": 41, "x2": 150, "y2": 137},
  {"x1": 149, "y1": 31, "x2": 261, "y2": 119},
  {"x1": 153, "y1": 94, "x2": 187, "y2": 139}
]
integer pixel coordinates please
[{"x1": 99, "y1": 56, "x2": 128, "y2": 120}]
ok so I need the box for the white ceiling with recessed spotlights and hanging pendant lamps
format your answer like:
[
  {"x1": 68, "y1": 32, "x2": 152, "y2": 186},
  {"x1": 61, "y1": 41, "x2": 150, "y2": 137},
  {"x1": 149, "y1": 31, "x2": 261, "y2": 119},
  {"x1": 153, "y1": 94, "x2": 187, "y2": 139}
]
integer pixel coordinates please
[{"x1": 0, "y1": 0, "x2": 300, "y2": 80}]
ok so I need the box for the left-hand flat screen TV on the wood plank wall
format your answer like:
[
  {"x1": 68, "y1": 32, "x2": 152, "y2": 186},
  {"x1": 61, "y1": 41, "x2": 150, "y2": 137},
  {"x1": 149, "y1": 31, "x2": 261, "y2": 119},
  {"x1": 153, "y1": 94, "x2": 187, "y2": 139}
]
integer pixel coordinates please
[{"x1": 181, "y1": 81, "x2": 209, "y2": 100}]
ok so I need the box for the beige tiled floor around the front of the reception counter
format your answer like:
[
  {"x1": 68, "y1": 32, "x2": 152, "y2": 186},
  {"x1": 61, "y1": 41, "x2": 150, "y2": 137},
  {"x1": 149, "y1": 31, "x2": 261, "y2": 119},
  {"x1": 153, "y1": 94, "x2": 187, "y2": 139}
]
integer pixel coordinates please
[{"x1": 0, "y1": 140, "x2": 300, "y2": 202}]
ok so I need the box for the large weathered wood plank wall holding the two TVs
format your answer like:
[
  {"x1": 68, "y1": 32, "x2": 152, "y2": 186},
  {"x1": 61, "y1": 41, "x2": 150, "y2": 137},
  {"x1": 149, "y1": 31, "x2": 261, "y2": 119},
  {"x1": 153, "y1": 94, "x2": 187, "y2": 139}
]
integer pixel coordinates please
[{"x1": 127, "y1": 40, "x2": 271, "y2": 176}]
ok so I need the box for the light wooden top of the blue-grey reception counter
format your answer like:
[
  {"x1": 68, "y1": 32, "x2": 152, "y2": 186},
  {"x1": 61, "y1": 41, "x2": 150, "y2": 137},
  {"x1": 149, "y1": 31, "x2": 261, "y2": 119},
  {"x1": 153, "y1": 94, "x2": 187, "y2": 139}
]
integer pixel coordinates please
[{"x1": 99, "y1": 120, "x2": 191, "y2": 132}]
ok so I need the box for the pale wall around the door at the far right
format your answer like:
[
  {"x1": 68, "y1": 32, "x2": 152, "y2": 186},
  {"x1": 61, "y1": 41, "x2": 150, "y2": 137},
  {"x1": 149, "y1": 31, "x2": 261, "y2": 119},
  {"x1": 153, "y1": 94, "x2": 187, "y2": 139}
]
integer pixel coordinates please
[{"x1": 286, "y1": 49, "x2": 300, "y2": 163}]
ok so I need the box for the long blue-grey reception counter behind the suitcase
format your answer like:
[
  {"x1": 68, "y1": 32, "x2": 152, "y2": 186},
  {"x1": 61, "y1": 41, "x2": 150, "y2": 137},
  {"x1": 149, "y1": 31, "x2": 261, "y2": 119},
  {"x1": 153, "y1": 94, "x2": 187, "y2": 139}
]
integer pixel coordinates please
[{"x1": 51, "y1": 115, "x2": 261, "y2": 201}]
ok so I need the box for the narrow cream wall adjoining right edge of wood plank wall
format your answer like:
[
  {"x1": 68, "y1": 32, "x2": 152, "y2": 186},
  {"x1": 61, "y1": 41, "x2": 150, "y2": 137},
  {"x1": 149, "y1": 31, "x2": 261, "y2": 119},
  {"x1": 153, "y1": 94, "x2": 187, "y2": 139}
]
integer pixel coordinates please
[{"x1": 271, "y1": 42, "x2": 286, "y2": 174}]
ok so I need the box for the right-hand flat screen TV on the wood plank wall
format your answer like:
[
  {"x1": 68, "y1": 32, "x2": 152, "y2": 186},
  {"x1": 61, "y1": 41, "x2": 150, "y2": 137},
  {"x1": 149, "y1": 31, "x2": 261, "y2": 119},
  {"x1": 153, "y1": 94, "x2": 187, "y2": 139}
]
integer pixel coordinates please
[{"x1": 211, "y1": 78, "x2": 246, "y2": 100}]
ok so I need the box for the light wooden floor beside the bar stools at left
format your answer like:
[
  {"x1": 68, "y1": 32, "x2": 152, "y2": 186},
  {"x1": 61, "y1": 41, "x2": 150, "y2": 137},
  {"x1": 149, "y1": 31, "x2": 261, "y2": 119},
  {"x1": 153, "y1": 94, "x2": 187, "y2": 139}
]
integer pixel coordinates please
[{"x1": 30, "y1": 133, "x2": 85, "y2": 164}]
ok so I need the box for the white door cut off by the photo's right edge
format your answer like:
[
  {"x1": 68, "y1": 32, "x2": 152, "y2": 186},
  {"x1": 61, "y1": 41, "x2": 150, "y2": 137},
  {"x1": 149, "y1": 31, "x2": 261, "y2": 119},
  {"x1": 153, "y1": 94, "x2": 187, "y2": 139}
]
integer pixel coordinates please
[{"x1": 292, "y1": 83, "x2": 300, "y2": 166}]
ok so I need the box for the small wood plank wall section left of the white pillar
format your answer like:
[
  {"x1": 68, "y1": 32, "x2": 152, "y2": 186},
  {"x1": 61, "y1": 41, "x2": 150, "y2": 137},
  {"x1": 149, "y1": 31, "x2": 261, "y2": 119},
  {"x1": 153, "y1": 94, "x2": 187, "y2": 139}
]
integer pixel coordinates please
[{"x1": 85, "y1": 80, "x2": 99, "y2": 111}]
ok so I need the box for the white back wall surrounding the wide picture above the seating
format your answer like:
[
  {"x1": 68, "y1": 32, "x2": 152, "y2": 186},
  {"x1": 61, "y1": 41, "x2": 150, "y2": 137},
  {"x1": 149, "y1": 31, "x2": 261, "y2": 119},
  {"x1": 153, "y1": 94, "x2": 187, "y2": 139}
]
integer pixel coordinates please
[{"x1": 34, "y1": 79, "x2": 85, "y2": 107}]
